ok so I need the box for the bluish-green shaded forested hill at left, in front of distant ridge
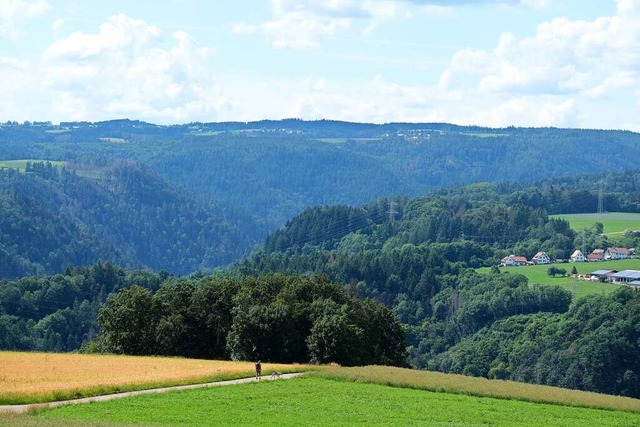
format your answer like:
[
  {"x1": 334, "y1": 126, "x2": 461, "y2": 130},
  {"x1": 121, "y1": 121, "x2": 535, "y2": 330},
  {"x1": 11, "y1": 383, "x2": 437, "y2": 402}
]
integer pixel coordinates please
[{"x1": 0, "y1": 163, "x2": 253, "y2": 278}]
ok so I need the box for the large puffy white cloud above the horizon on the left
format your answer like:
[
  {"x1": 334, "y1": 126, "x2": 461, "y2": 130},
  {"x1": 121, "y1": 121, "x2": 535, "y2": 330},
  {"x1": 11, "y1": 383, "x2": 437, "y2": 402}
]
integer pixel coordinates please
[{"x1": 35, "y1": 14, "x2": 227, "y2": 123}]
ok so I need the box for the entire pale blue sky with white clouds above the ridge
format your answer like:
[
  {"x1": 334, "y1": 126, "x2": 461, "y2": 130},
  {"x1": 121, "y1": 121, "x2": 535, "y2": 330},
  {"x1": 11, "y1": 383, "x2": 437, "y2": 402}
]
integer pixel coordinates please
[{"x1": 0, "y1": 0, "x2": 640, "y2": 131}]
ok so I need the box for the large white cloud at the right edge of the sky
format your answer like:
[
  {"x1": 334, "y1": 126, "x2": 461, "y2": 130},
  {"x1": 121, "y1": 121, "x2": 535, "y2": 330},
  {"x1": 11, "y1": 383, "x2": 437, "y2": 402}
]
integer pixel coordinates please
[{"x1": 439, "y1": 0, "x2": 640, "y2": 126}]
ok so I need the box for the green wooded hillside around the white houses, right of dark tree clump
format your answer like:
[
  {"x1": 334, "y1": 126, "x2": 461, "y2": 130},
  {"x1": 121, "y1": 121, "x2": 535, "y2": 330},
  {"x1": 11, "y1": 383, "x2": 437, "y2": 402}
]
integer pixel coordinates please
[{"x1": 236, "y1": 172, "x2": 640, "y2": 397}]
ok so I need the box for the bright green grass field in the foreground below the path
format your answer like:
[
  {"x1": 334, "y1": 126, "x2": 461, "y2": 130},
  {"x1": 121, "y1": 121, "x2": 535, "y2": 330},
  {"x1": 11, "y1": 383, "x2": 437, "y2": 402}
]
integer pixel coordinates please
[{"x1": 33, "y1": 377, "x2": 640, "y2": 426}]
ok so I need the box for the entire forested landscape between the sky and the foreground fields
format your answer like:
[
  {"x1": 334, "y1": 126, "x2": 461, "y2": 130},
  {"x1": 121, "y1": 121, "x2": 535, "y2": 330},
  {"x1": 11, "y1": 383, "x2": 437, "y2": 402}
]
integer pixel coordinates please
[{"x1": 0, "y1": 120, "x2": 640, "y2": 397}]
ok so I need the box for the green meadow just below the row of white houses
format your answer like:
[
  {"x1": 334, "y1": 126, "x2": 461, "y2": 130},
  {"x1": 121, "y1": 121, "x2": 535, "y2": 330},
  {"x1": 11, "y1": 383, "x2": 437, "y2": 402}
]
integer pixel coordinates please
[{"x1": 478, "y1": 259, "x2": 640, "y2": 298}]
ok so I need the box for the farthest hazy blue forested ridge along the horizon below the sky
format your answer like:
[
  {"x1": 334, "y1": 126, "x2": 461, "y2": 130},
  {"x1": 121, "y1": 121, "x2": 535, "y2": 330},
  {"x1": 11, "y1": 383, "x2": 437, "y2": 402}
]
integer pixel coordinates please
[{"x1": 0, "y1": 120, "x2": 640, "y2": 237}]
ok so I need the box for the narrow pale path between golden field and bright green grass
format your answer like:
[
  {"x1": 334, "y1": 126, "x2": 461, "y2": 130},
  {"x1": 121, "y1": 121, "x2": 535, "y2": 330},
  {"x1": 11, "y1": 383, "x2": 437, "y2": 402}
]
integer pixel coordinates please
[{"x1": 0, "y1": 372, "x2": 303, "y2": 414}]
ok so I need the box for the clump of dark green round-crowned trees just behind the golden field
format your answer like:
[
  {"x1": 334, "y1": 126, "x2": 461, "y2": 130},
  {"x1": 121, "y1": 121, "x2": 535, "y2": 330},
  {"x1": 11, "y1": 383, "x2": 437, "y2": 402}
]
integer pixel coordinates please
[{"x1": 91, "y1": 275, "x2": 406, "y2": 366}]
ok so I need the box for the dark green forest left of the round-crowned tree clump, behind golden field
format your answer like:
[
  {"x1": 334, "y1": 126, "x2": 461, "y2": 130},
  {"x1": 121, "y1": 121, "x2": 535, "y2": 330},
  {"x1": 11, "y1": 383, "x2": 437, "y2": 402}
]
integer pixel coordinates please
[{"x1": 0, "y1": 263, "x2": 162, "y2": 351}]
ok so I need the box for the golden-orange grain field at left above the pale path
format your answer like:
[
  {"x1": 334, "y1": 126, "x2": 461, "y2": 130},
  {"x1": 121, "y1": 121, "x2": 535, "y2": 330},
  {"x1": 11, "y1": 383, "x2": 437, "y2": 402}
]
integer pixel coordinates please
[{"x1": 0, "y1": 352, "x2": 310, "y2": 404}]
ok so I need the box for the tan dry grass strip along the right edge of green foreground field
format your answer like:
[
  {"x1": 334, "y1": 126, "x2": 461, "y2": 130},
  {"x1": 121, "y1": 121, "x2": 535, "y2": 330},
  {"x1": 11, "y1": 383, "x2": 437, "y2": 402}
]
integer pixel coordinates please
[{"x1": 321, "y1": 366, "x2": 640, "y2": 412}]
